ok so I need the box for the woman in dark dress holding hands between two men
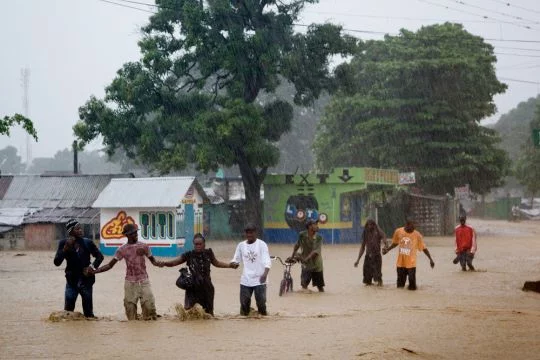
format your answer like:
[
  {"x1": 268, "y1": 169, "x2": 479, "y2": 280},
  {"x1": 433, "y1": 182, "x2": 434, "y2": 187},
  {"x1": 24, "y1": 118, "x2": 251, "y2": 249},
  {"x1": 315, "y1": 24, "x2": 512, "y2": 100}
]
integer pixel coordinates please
[{"x1": 158, "y1": 234, "x2": 238, "y2": 316}]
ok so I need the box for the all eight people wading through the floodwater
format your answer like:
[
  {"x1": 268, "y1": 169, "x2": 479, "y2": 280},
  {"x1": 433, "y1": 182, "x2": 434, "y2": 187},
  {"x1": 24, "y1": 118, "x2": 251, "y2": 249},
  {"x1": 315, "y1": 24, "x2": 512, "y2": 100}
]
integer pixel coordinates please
[{"x1": 54, "y1": 216, "x2": 476, "y2": 320}]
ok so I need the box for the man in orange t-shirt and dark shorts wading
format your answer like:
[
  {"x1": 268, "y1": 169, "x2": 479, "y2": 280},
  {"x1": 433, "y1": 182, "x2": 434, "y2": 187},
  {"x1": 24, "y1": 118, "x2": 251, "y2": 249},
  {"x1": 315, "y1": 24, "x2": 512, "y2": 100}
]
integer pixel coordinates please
[{"x1": 382, "y1": 220, "x2": 435, "y2": 290}]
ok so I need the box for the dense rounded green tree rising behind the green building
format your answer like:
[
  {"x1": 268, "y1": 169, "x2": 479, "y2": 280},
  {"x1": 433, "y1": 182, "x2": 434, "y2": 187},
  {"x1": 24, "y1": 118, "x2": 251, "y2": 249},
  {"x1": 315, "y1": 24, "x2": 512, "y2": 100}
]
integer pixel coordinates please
[{"x1": 315, "y1": 23, "x2": 508, "y2": 194}]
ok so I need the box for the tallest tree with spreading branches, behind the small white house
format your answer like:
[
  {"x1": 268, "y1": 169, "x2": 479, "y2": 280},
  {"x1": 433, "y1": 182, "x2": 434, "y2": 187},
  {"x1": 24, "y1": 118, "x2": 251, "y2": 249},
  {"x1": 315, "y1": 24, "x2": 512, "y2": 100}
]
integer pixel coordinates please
[{"x1": 74, "y1": 0, "x2": 355, "y2": 228}]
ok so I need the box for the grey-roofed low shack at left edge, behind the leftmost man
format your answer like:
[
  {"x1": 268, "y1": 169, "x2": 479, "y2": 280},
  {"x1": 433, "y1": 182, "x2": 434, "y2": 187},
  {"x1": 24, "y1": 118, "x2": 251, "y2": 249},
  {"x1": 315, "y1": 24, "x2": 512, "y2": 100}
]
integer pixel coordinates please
[{"x1": 0, "y1": 174, "x2": 133, "y2": 250}]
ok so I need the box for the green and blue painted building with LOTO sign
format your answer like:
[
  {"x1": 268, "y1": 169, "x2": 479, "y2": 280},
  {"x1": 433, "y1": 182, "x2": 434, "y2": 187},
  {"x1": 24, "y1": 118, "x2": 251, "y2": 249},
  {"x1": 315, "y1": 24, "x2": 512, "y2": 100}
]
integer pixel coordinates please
[{"x1": 264, "y1": 168, "x2": 399, "y2": 244}]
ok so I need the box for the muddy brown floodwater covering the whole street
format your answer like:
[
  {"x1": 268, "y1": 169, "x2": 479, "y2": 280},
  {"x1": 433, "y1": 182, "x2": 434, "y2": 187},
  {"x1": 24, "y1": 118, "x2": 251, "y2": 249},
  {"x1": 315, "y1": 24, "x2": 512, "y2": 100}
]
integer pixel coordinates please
[{"x1": 0, "y1": 219, "x2": 540, "y2": 360}]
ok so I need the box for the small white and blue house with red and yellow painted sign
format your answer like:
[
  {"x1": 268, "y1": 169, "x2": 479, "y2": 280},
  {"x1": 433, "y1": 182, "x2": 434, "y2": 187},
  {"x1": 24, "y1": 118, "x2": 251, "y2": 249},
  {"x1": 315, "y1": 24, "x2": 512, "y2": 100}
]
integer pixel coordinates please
[{"x1": 93, "y1": 177, "x2": 208, "y2": 256}]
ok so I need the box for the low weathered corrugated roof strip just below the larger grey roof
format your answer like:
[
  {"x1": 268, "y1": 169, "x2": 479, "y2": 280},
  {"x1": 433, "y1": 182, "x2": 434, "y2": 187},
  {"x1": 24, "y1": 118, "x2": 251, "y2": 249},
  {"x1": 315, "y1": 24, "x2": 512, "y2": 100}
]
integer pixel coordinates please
[{"x1": 23, "y1": 208, "x2": 99, "y2": 224}]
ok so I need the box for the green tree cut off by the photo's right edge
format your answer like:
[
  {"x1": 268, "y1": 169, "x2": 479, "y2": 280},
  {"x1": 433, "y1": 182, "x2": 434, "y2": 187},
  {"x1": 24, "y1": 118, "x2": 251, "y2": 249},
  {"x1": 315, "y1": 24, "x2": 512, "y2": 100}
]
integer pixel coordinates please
[{"x1": 516, "y1": 103, "x2": 540, "y2": 204}]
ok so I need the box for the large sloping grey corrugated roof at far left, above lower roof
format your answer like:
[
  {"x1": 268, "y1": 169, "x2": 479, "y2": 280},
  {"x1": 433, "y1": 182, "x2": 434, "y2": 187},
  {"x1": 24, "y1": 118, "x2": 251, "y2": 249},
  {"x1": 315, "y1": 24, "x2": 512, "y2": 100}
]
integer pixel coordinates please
[{"x1": 0, "y1": 174, "x2": 133, "y2": 208}]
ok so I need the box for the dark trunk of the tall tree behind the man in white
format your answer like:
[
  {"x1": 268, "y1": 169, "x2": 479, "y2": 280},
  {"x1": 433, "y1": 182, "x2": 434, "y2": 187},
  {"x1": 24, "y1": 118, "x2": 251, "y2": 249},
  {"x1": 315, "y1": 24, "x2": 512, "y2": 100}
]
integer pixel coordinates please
[{"x1": 238, "y1": 156, "x2": 266, "y2": 237}]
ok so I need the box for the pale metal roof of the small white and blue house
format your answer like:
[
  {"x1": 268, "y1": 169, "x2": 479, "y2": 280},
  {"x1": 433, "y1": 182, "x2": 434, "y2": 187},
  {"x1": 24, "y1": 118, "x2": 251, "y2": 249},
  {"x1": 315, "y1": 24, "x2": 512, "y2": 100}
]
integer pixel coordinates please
[{"x1": 93, "y1": 176, "x2": 208, "y2": 208}]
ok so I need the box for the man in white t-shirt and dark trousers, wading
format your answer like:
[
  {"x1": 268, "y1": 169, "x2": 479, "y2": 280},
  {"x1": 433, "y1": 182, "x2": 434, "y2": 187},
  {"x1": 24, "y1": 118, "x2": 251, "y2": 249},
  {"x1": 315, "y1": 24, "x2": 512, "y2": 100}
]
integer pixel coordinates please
[{"x1": 231, "y1": 224, "x2": 271, "y2": 316}]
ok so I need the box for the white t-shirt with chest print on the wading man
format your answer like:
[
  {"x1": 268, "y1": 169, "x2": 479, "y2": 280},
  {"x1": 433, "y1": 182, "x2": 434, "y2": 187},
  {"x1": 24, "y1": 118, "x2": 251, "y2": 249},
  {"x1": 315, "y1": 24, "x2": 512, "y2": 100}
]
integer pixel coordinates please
[{"x1": 231, "y1": 239, "x2": 272, "y2": 287}]
